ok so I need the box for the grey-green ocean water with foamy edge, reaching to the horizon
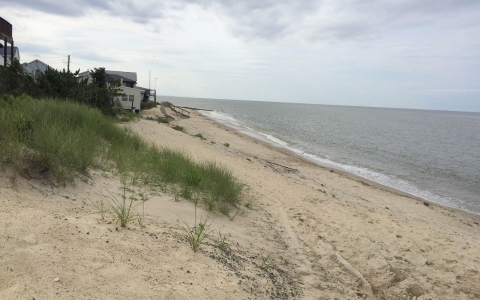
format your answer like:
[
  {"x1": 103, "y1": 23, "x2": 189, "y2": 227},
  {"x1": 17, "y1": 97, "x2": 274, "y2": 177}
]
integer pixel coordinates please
[{"x1": 158, "y1": 97, "x2": 480, "y2": 214}]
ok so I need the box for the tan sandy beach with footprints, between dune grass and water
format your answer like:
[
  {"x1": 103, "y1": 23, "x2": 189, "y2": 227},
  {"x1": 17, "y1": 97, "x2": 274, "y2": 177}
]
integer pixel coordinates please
[{"x1": 0, "y1": 108, "x2": 480, "y2": 300}]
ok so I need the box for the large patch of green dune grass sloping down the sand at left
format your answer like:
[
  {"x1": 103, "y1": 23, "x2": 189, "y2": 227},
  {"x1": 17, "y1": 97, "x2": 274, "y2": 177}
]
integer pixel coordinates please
[{"x1": 0, "y1": 96, "x2": 244, "y2": 213}]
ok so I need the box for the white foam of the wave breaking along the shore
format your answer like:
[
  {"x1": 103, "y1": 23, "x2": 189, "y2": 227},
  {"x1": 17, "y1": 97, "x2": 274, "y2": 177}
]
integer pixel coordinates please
[{"x1": 200, "y1": 111, "x2": 475, "y2": 213}]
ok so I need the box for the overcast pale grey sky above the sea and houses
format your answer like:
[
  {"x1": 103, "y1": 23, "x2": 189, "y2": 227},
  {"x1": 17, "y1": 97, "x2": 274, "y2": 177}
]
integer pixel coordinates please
[{"x1": 0, "y1": 0, "x2": 480, "y2": 112}]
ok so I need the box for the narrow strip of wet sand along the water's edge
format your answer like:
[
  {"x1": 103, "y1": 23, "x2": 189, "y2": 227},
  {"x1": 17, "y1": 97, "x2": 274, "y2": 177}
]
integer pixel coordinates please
[{"x1": 195, "y1": 107, "x2": 480, "y2": 218}]
